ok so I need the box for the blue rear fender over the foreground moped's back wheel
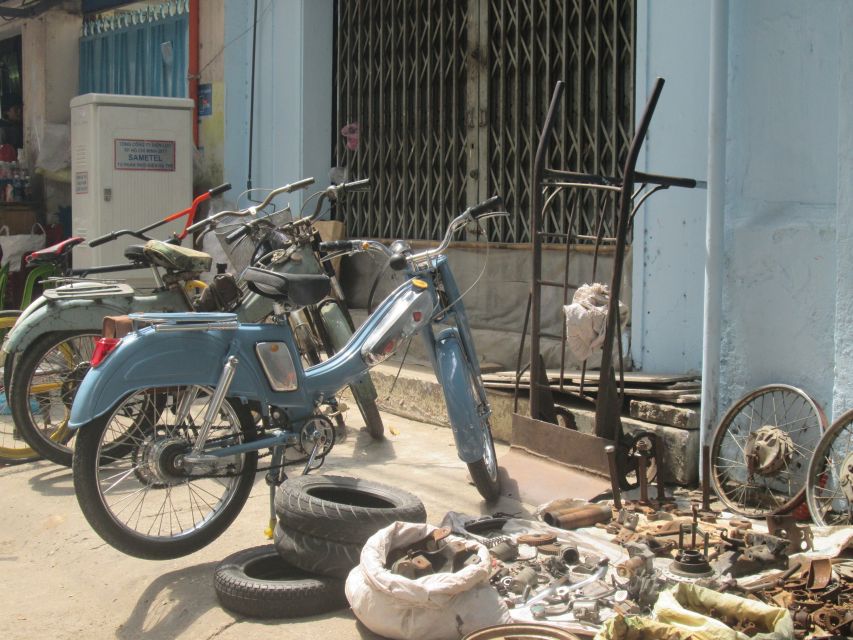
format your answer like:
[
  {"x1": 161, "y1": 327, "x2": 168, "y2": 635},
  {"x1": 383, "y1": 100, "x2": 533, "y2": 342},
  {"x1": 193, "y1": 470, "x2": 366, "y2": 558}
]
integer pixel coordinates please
[{"x1": 68, "y1": 324, "x2": 288, "y2": 429}]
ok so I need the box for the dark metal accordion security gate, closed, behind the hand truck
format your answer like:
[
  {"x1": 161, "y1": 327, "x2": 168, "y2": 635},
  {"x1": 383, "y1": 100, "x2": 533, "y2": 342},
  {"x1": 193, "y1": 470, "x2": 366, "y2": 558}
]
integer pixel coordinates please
[{"x1": 335, "y1": 0, "x2": 635, "y2": 243}]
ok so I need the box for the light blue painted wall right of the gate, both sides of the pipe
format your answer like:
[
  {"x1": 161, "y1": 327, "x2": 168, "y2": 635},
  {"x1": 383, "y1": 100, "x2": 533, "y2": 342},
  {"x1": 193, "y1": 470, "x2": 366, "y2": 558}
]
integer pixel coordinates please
[{"x1": 632, "y1": 0, "x2": 853, "y2": 428}]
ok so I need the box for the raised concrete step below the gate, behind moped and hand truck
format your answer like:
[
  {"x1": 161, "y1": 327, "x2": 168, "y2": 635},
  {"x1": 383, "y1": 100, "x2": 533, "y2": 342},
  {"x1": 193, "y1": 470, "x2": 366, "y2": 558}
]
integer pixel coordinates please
[{"x1": 362, "y1": 359, "x2": 699, "y2": 486}]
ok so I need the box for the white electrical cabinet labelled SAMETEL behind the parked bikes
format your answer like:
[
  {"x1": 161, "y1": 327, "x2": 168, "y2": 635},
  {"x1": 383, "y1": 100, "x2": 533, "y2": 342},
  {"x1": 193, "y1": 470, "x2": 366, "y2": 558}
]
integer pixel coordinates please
[{"x1": 71, "y1": 93, "x2": 193, "y2": 287}]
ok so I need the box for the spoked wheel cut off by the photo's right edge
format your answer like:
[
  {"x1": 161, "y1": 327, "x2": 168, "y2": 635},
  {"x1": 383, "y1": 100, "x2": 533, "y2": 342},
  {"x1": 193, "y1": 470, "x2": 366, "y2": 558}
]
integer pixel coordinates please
[{"x1": 806, "y1": 410, "x2": 853, "y2": 526}]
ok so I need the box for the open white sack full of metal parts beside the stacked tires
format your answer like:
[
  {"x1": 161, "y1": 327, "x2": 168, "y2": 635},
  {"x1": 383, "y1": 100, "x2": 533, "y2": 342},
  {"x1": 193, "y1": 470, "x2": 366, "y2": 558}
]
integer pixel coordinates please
[{"x1": 346, "y1": 522, "x2": 512, "y2": 640}]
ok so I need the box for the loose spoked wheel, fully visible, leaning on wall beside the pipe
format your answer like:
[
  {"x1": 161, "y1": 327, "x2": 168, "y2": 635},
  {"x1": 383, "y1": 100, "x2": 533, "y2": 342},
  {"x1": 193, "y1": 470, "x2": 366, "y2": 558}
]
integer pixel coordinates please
[{"x1": 711, "y1": 385, "x2": 826, "y2": 518}]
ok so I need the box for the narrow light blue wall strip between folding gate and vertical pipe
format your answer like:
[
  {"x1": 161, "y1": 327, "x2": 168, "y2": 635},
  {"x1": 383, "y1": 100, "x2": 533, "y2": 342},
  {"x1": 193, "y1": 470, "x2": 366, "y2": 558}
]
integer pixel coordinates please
[{"x1": 631, "y1": 0, "x2": 709, "y2": 373}]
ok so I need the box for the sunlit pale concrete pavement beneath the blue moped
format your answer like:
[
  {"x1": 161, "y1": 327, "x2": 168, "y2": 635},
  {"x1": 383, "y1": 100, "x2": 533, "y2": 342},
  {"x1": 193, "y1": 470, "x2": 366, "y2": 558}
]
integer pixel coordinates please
[{"x1": 0, "y1": 411, "x2": 529, "y2": 640}]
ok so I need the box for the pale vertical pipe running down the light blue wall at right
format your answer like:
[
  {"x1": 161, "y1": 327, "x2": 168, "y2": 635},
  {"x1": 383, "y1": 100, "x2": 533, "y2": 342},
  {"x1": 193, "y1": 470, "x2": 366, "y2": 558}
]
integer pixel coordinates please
[{"x1": 699, "y1": 0, "x2": 729, "y2": 476}]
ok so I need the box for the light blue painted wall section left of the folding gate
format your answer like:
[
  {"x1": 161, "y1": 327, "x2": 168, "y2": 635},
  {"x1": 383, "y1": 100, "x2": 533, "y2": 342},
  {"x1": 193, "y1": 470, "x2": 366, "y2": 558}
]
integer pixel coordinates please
[{"x1": 224, "y1": 0, "x2": 333, "y2": 208}]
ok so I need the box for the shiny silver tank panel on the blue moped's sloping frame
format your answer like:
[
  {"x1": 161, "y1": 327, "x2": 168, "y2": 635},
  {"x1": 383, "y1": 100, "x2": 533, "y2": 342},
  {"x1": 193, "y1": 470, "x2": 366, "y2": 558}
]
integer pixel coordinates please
[{"x1": 361, "y1": 288, "x2": 433, "y2": 367}]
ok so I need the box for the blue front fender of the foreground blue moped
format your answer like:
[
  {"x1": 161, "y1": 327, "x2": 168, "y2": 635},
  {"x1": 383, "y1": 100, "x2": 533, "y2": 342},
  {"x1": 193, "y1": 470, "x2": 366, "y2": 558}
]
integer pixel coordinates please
[{"x1": 434, "y1": 327, "x2": 488, "y2": 463}]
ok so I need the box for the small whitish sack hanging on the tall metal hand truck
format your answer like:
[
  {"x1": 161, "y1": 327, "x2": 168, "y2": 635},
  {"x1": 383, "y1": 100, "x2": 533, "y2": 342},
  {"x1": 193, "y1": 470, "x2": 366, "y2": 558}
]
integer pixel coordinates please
[{"x1": 563, "y1": 282, "x2": 628, "y2": 360}]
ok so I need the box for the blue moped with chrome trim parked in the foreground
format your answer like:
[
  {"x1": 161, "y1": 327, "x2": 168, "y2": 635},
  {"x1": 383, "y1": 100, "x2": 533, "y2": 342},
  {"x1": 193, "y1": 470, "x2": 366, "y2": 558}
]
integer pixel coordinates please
[{"x1": 69, "y1": 197, "x2": 507, "y2": 559}]
